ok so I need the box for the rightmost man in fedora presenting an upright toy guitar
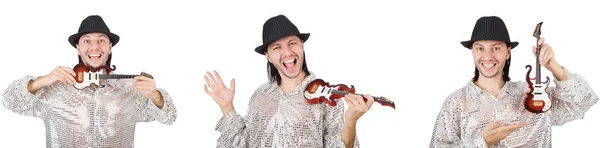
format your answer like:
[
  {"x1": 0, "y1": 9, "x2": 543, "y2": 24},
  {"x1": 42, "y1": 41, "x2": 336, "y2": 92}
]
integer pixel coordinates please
[{"x1": 430, "y1": 16, "x2": 598, "y2": 147}]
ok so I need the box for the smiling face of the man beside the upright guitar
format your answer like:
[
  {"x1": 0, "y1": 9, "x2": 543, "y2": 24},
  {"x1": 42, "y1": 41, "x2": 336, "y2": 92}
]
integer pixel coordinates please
[{"x1": 471, "y1": 40, "x2": 511, "y2": 78}]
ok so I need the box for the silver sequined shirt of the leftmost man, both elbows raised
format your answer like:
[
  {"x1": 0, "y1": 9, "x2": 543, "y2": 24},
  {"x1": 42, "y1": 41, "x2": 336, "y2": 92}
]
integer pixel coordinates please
[{"x1": 2, "y1": 76, "x2": 177, "y2": 148}]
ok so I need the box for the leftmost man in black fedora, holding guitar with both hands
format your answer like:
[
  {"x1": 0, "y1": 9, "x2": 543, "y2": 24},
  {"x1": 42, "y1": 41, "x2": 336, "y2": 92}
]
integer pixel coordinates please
[{"x1": 3, "y1": 15, "x2": 177, "y2": 147}]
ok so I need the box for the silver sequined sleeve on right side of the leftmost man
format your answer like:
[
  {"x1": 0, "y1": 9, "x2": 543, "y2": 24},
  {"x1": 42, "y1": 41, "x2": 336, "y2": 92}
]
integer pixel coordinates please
[{"x1": 137, "y1": 88, "x2": 177, "y2": 125}]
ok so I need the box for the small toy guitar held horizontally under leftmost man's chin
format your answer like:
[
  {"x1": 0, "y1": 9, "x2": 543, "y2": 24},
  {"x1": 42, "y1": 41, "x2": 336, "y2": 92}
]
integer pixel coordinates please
[{"x1": 73, "y1": 64, "x2": 154, "y2": 90}]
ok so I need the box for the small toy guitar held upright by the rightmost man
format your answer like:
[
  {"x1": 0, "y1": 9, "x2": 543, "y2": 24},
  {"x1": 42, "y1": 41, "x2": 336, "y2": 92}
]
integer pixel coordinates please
[{"x1": 523, "y1": 22, "x2": 552, "y2": 113}]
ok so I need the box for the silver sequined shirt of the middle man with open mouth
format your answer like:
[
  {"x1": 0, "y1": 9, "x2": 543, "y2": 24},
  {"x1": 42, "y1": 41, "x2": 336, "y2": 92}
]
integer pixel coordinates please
[{"x1": 216, "y1": 72, "x2": 359, "y2": 148}]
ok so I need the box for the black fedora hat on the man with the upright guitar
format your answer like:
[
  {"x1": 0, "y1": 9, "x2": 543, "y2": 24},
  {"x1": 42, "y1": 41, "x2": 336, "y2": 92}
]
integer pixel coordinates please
[{"x1": 460, "y1": 16, "x2": 519, "y2": 49}]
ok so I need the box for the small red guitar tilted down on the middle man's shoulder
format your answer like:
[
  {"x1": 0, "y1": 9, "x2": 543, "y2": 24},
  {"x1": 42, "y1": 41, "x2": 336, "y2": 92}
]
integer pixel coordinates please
[{"x1": 304, "y1": 79, "x2": 396, "y2": 109}]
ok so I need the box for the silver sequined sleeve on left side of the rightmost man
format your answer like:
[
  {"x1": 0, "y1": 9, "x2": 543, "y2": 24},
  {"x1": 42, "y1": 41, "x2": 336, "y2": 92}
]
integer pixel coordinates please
[{"x1": 429, "y1": 92, "x2": 488, "y2": 148}]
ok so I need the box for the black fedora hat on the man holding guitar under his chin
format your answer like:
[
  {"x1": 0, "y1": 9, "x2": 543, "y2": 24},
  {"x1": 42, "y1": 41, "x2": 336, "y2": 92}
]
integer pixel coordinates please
[{"x1": 69, "y1": 15, "x2": 119, "y2": 48}]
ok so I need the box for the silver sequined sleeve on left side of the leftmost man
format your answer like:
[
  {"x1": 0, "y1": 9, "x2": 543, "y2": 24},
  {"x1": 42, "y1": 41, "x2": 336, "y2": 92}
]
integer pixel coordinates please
[{"x1": 2, "y1": 76, "x2": 49, "y2": 117}]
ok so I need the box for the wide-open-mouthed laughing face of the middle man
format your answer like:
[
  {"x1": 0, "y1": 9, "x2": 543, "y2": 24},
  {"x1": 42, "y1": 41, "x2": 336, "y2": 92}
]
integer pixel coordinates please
[{"x1": 265, "y1": 35, "x2": 304, "y2": 79}]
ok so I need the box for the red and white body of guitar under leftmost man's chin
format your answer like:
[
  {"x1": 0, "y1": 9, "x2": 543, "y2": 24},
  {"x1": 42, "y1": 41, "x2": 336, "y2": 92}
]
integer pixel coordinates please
[{"x1": 73, "y1": 64, "x2": 114, "y2": 90}]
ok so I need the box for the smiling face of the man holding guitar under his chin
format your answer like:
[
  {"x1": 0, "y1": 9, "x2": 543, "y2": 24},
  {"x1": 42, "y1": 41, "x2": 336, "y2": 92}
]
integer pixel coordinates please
[{"x1": 77, "y1": 33, "x2": 112, "y2": 68}]
